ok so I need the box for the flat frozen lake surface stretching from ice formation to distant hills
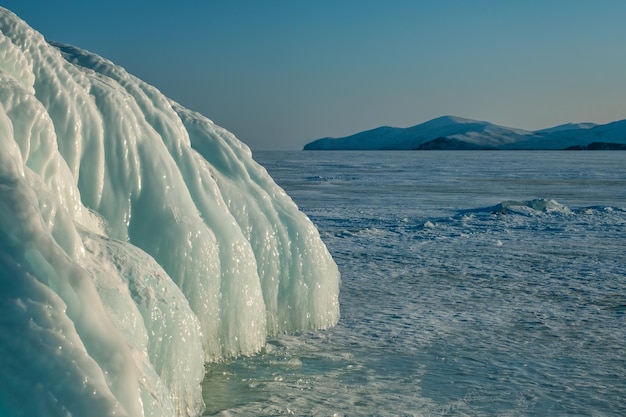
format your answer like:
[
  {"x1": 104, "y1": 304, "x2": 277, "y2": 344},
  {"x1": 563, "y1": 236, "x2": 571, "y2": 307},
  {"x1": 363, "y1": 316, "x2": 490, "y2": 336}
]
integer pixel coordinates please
[{"x1": 205, "y1": 152, "x2": 626, "y2": 416}]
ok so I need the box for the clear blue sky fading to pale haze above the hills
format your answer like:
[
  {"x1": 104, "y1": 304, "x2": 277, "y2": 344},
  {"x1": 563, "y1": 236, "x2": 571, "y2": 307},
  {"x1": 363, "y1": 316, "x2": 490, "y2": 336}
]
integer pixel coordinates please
[{"x1": 0, "y1": 0, "x2": 626, "y2": 150}]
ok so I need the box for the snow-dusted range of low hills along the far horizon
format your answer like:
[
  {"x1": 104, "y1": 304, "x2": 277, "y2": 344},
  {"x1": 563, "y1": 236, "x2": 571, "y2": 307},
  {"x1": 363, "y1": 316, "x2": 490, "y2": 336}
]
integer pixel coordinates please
[{"x1": 304, "y1": 116, "x2": 626, "y2": 150}]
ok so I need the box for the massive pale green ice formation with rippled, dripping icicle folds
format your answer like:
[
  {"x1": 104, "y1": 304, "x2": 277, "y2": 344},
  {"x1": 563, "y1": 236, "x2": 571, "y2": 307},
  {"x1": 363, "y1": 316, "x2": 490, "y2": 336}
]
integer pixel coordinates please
[{"x1": 0, "y1": 8, "x2": 339, "y2": 417}]
